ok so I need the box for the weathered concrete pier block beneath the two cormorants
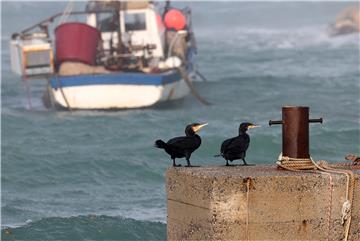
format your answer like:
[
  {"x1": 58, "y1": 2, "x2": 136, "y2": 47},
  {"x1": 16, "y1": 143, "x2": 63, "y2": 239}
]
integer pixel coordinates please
[{"x1": 166, "y1": 165, "x2": 360, "y2": 241}]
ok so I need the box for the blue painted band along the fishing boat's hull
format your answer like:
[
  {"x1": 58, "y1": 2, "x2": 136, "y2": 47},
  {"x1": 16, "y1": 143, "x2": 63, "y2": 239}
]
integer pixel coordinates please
[{"x1": 51, "y1": 70, "x2": 181, "y2": 89}]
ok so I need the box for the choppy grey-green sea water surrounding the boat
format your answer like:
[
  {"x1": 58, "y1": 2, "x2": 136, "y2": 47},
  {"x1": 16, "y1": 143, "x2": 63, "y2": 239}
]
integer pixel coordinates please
[{"x1": 1, "y1": 2, "x2": 360, "y2": 240}]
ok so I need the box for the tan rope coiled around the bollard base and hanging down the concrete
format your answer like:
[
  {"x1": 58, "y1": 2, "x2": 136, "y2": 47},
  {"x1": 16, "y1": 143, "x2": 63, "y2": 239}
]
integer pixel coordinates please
[{"x1": 276, "y1": 153, "x2": 357, "y2": 241}]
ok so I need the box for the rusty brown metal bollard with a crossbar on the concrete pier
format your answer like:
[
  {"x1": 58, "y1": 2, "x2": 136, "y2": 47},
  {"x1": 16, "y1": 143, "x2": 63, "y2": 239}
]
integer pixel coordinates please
[{"x1": 269, "y1": 106, "x2": 323, "y2": 158}]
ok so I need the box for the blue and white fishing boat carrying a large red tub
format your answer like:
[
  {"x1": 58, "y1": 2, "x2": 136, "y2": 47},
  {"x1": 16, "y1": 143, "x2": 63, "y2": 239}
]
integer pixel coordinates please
[{"x1": 10, "y1": 1, "x2": 205, "y2": 110}]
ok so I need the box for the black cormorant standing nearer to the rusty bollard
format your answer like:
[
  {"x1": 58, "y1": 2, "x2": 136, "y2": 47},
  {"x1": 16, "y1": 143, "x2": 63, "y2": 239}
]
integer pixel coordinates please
[{"x1": 216, "y1": 122, "x2": 259, "y2": 166}]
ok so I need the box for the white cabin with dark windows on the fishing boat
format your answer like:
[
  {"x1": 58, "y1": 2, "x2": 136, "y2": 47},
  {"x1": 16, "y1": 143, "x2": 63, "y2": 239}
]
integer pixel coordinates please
[{"x1": 86, "y1": 1, "x2": 165, "y2": 61}]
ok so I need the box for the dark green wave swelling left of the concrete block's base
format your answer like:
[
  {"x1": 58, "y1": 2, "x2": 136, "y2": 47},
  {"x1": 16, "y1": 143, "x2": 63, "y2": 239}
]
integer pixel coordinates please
[{"x1": 1, "y1": 215, "x2": 166, "y2": 241}]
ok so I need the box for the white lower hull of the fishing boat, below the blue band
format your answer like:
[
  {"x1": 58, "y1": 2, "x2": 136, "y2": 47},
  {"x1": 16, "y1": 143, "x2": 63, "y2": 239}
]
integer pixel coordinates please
[{"x1": 51, "y1": 79, "x2": 190, "y2": 109}]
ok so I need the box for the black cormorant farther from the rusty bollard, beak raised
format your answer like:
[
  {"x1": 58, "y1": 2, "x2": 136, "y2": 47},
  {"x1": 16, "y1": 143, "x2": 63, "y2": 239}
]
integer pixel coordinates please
[{"x1": 155, "y1": 123, "x2": 207, "y2": 167}]
